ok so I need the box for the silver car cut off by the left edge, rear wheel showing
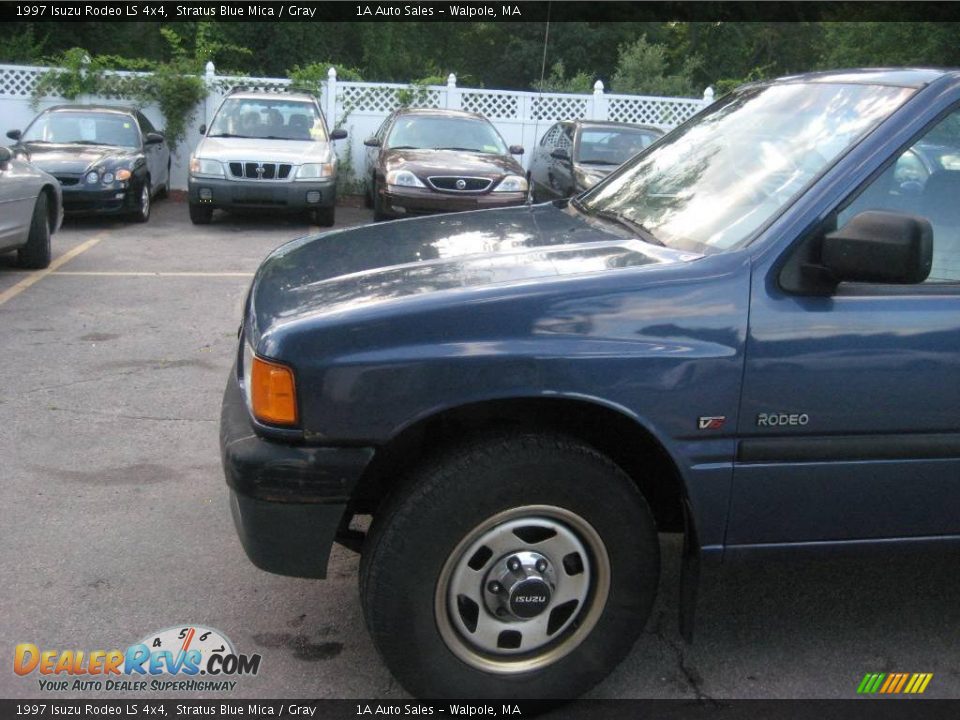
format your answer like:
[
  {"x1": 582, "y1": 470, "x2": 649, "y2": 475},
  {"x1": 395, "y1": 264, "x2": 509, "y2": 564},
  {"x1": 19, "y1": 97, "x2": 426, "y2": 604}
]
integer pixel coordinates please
[{"x1": 0, "y1": 147, "x2": 63, "y2": 268}]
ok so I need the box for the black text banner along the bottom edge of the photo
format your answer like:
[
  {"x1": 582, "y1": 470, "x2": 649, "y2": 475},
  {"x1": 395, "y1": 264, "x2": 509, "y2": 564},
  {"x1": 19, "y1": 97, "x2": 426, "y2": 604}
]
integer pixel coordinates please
[{"x1": 0, "y1": 698, "x2": 960, "y2": 720}]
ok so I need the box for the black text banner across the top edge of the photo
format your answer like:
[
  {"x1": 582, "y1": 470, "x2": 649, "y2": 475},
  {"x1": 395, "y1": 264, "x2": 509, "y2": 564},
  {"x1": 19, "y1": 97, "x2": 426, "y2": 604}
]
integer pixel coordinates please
[{"x1": 0, "y1": 0, "x2": 960, "y2": 22}]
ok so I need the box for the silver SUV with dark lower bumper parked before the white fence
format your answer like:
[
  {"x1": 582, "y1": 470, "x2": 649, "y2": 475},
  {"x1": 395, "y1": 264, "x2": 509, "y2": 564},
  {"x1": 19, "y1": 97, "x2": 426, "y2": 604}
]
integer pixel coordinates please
[{"x1": 189, "y1": 92, "x2": 347, "y2": 226}]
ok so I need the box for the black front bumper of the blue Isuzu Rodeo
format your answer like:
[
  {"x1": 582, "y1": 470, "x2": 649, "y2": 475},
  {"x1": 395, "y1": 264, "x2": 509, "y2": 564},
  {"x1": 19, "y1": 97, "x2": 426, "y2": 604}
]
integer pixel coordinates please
[{"x1": 220, "y1": 369, "x2": 374, "y2": 578}]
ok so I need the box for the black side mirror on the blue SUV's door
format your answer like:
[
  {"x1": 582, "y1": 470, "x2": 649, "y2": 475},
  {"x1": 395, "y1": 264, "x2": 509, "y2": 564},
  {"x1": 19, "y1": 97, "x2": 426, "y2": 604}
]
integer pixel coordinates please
[{"x1": 820, "y1": 210, "x2": 933, "y2": 285}]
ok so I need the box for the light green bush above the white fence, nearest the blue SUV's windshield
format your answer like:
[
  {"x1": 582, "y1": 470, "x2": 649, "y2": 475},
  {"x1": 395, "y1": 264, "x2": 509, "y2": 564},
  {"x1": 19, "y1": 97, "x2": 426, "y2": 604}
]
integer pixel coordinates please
[{"x1": 613, "y1": 35, "x2": 701, "y2": 97}]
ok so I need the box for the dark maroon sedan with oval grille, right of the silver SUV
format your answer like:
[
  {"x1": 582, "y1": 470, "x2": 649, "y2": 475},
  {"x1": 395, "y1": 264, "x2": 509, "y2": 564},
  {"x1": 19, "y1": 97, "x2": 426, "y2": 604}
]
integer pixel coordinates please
[{"x1": 364, "y1": 109, "x2": 527, "y2": 220}]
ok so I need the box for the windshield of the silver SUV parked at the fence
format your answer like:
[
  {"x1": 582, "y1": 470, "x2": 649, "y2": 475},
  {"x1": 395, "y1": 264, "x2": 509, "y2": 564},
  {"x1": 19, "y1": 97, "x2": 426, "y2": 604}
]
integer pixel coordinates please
[{"x1": 207, "y1": 98, "x2": 327, "y2": 142}]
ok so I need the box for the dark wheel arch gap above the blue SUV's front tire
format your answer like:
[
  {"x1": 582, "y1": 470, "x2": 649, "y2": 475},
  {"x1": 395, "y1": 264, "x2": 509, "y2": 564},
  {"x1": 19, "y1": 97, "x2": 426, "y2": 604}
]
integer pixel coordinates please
[{"x1": 353, "y1": 397, "x2": 686, "y2": 532}]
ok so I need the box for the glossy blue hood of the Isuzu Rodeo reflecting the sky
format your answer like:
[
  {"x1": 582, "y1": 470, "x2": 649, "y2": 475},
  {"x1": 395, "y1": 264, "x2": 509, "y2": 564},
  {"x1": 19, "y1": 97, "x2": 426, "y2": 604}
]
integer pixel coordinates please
[{"x1": 247, "y1": 204, "x2": 701, "y2": 345}]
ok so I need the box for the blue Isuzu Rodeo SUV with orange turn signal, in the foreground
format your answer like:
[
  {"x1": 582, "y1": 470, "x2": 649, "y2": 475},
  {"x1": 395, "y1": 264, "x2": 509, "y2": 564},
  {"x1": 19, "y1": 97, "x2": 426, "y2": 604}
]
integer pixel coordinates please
[{"x1": 221, "y1": 69, "x2": 960, "y2": 698}]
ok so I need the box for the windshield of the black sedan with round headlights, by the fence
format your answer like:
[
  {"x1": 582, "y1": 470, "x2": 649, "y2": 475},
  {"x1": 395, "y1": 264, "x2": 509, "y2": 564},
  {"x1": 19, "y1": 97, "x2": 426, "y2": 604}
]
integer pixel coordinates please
[{"x1": 21, "y1": 110, "x2": 140, "y2": 148}]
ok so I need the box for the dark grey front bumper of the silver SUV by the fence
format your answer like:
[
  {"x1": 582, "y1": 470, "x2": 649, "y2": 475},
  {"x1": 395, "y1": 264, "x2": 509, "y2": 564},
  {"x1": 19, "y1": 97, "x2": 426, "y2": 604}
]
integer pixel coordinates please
[{"x1": 187, "y1": 176, "x2": 337, "y2": 211}]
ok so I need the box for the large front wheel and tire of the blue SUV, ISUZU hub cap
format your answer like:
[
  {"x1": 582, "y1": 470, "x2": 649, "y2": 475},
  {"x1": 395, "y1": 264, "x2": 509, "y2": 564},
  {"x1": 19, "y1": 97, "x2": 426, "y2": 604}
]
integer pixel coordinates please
[{"x1": 360, "y1": 434, "x2": 659, "y2": 699}]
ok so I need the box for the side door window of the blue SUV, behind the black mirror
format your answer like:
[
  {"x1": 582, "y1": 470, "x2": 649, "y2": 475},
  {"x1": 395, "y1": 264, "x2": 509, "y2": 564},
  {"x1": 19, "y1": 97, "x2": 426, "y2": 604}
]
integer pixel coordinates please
[{"x1": 837, "y1": 110, "x2": 960, "y2": 283}]
